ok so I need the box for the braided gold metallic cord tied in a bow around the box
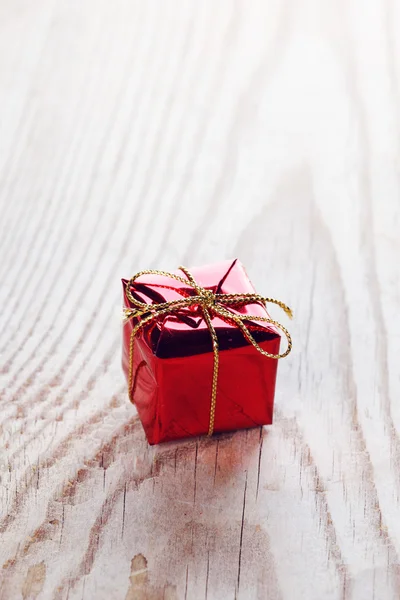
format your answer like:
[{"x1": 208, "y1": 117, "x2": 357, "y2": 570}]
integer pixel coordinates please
[{"x1": 124, "y1": 267, "x2": 293, "y2": 435}]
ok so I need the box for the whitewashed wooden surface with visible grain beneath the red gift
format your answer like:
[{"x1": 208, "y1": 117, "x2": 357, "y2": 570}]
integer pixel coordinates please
[{"x1": 0, "y1": 0, "x2": 400, "y2": 600}]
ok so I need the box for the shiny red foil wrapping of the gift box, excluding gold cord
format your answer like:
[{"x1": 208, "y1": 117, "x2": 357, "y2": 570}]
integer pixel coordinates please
[{"x1": 122, "y1": 260, "x2": 281, "y2": 444}]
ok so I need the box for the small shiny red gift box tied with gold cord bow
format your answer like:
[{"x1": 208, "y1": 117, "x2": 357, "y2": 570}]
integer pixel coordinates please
[{"x1": 122, "y1": 260, "x2": 292, "y2": 444}]
